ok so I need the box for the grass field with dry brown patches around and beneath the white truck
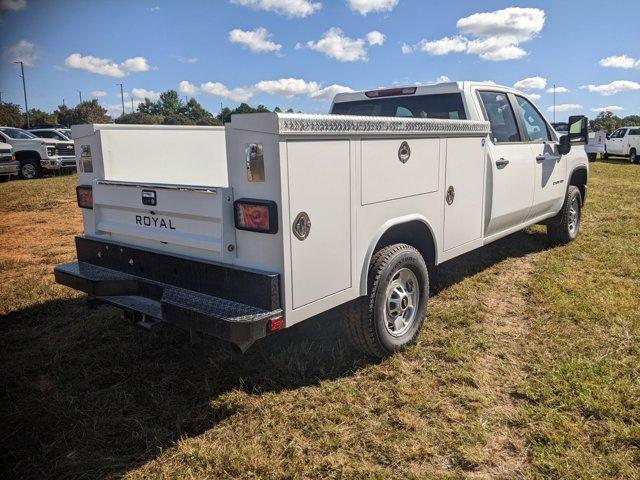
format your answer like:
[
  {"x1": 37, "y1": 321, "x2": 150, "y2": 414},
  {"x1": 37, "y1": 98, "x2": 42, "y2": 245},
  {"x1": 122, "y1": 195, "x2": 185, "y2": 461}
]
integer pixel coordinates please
[{"x1": 0, "y1": 160, "x2": 640, "y2": 479}]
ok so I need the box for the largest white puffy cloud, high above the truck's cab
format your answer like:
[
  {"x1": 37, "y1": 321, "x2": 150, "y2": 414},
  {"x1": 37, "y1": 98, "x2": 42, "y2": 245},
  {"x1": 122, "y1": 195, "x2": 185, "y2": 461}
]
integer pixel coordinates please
[{"x1": 416, "y1": 7, "x2": 545, "y2": 62}]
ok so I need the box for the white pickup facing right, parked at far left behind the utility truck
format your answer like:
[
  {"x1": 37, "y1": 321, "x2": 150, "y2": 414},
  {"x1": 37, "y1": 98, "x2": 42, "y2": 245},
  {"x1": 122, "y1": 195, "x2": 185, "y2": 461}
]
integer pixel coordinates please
[{"x1": 0, "y1": 127, "x2": 76, "y2": 179}]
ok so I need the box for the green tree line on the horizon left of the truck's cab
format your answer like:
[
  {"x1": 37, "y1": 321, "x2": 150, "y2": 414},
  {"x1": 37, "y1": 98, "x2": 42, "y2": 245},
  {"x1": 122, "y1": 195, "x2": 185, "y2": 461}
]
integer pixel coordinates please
[{"x1": 0, "y1": 90, "x2": 293, "y2": 128}]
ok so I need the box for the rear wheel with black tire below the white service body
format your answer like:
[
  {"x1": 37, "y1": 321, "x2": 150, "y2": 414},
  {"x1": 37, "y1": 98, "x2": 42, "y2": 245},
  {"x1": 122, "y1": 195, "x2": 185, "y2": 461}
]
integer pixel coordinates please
[{"x1": 346, "y1": 243, "x2": 429, "y2": 358}]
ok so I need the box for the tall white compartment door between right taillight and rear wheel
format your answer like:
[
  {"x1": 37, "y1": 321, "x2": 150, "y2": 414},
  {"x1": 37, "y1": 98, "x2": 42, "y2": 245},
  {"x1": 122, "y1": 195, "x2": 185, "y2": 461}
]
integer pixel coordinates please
[{"x1": 285, "y1": 140, "x2": 351, "y2": 309}]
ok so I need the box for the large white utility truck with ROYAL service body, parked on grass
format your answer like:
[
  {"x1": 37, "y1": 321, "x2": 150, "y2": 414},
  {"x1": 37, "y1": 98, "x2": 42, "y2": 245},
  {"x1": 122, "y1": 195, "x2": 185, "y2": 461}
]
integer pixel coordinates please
[{"x1": 55, "y1": 82, "x2": 588, "y2": 356}]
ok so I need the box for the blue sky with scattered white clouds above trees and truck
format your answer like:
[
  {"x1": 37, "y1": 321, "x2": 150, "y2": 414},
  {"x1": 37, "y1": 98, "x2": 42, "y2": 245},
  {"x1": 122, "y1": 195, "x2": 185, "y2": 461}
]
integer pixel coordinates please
[{"x1": 0, "y1": 0, "x2": 640, "y2": 119}]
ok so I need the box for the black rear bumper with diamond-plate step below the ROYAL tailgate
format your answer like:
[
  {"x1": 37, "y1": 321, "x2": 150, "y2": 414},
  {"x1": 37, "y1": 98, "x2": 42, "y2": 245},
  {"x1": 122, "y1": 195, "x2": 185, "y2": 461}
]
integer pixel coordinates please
[{"x1": 54, "y1": 237, "x2": 282, "y2": 350}]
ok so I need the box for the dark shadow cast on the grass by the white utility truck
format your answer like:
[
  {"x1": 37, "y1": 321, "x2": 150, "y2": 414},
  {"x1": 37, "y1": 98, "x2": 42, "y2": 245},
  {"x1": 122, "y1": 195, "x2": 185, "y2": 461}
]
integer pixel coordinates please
[{"x1": 0, "y1": 233, "x2": 548, "y2": 478}]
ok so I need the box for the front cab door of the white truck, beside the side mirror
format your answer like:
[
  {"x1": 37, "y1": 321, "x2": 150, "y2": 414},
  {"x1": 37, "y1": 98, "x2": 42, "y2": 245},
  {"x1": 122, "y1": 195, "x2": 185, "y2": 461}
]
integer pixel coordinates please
[{"x1": 514, "y1": 95, "x2": 567, "y2": 220}]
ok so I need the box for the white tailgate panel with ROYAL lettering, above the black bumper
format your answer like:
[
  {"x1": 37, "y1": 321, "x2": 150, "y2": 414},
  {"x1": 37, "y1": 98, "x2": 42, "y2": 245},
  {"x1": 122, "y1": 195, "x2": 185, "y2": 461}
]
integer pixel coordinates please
[{"x1": 93, "y1": 180, "x2": 235, "y2": 257}]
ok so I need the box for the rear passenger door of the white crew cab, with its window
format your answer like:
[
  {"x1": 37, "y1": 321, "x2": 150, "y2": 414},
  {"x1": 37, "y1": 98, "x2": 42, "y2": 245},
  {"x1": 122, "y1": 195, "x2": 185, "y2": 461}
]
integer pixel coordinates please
[{"x1": 478, "y1": 91, "x2": 535, "y2": 236}]
